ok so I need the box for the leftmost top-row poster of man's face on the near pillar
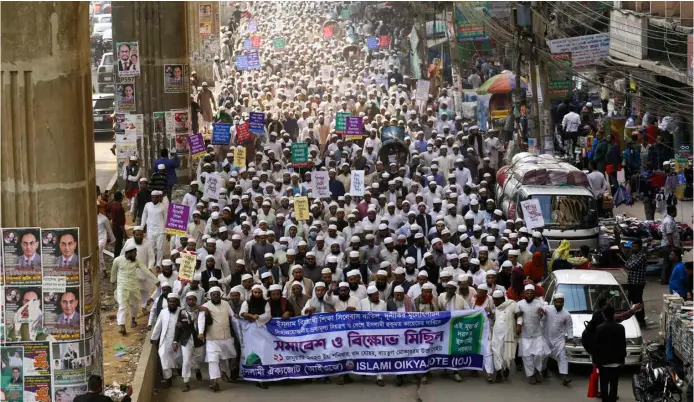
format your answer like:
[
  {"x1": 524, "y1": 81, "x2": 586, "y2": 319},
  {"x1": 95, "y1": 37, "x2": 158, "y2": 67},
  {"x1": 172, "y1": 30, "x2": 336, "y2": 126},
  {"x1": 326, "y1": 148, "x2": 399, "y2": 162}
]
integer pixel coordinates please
[{"x1": 0, "y1": 228, "x2": 42, "y2": 286}]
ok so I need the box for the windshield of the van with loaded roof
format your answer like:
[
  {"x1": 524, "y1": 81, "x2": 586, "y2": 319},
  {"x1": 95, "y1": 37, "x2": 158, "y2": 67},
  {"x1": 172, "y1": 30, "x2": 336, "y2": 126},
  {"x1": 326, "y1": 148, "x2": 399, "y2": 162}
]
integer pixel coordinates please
[{"x1": 520, "y1": 194, "x2": 598, "y2": 229}]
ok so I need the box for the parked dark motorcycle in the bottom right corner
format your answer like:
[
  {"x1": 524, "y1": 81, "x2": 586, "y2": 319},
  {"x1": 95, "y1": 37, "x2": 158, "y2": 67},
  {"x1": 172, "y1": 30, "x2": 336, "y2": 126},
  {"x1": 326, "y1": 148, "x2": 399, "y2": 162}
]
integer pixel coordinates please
[{"x1": 631, "y1": 343, "x2": 685, "y2": 402}]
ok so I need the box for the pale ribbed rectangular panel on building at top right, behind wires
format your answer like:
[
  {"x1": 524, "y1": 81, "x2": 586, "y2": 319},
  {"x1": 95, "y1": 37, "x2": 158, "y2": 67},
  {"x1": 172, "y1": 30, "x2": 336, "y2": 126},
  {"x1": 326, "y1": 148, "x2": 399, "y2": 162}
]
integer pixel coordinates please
[{"x1": 610, "y1": 10, "x2": 648, "y2": 59}]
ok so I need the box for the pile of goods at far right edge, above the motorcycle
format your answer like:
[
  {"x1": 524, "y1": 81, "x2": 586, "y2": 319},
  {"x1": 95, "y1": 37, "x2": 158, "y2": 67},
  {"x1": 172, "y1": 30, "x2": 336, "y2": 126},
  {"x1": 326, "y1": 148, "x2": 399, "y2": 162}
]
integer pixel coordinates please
[{"x1": 660, "y1": 295, "x2": 694, "y2": 364}]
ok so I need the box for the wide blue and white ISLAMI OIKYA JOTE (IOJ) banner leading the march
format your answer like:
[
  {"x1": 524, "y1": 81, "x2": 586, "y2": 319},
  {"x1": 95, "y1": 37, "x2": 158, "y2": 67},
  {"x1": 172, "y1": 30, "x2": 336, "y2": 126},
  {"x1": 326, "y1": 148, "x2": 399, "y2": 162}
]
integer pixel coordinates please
[{"x1": 240, "y1": 310, "x2": 489, "y2": 381}]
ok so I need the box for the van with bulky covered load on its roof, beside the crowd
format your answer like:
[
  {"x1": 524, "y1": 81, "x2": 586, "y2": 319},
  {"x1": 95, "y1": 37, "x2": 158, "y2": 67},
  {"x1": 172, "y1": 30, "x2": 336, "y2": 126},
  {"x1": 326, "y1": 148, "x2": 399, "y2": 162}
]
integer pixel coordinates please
[{"x1": 494, "y1": 152, "x2": 600, "y2": 250}]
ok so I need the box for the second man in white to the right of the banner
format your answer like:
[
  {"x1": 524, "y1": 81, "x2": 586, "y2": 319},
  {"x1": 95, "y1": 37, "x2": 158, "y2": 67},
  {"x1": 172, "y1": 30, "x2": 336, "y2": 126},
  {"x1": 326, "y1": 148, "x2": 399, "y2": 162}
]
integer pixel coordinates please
[{"x1": 516, "y1": 284, "x2": 549, "y2": 384}]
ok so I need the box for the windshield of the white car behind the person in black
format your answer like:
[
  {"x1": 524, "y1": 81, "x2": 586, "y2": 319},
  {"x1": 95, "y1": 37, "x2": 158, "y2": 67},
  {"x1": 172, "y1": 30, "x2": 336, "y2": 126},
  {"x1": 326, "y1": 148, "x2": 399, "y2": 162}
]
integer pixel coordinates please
[{"x1": 555, "y1": 284, "x2": 630, "y2": 314}]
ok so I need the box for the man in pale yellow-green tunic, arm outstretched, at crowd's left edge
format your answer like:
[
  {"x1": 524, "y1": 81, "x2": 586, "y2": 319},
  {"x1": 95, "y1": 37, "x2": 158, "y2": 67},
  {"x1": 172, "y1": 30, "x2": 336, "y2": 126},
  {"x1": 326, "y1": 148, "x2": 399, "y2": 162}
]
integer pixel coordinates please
[{"x1": 111, "y1": 244, "x2": 157, "y2": 335}]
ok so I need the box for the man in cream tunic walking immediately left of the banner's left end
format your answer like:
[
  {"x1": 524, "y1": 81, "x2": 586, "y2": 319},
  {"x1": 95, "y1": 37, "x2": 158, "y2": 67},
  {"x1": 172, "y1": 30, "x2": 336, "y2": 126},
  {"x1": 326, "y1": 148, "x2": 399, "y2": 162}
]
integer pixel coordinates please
[{"x1": 198, "y1": 286, "x2": 239, "y2": 392}]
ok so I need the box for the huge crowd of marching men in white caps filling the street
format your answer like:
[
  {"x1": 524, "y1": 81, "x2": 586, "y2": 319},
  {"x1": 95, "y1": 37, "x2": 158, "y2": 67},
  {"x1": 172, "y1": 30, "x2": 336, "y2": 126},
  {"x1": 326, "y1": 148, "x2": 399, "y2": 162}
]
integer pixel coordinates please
[{"x1": 102, "y1": 2, "x2": 652, "y2": 391}]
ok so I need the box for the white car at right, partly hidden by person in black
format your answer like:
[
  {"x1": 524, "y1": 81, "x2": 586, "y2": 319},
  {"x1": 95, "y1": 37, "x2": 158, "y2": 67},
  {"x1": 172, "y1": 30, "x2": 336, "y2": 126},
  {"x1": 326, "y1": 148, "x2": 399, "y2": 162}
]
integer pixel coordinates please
[{"x1": 542, "y1": 269, "x2": 643, "y2": 365}]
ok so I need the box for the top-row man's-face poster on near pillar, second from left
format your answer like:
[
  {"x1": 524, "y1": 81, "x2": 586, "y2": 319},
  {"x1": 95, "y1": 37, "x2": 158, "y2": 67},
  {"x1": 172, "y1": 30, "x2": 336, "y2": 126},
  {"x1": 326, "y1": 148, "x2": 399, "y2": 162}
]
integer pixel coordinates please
[{"x1": 41, "y1": 228, "x2": 80, "y2": 286}]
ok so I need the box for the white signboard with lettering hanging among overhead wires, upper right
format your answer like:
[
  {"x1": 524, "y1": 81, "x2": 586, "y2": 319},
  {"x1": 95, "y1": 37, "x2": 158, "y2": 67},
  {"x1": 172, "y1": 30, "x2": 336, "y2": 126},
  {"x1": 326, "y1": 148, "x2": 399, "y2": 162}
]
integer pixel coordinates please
[{"x1": 547, "y1": 33, "x2": 610, "y2": 67}]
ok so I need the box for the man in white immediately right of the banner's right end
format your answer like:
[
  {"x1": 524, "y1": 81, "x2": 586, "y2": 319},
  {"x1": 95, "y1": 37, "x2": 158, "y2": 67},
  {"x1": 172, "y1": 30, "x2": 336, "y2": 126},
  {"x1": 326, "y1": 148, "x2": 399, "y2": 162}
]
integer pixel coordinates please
[{"x1": 491, "y1": 290, "x2": 518, "y2": 382}]
